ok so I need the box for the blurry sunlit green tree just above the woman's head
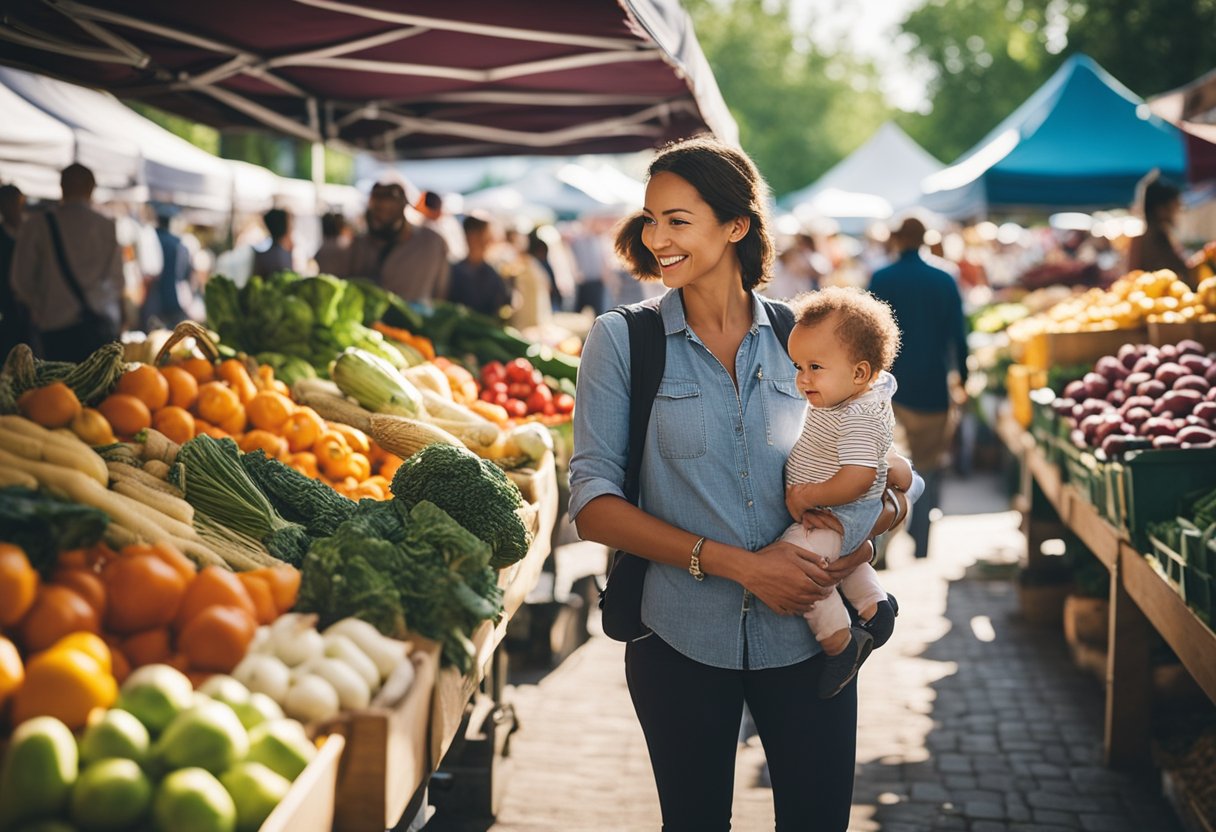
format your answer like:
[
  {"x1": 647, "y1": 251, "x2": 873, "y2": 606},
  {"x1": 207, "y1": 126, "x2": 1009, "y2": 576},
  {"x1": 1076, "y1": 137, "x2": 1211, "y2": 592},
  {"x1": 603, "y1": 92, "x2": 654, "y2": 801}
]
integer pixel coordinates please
[{"x1": 685, "y1": 0, "x2": 891, "y2": 195}]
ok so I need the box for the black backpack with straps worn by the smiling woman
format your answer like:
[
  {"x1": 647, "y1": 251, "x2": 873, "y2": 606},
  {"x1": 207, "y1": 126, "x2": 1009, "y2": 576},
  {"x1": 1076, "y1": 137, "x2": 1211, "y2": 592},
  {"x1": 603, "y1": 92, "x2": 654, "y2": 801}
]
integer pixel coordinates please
[{"x1": 599, "y1": 296, "x2": 794, "y2": 641}]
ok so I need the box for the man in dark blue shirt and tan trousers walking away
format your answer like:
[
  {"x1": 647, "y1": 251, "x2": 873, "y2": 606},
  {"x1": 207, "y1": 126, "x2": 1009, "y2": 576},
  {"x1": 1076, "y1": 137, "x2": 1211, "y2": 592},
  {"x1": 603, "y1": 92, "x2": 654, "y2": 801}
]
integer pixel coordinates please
[{"x1": 869, "y1": 217, "x2": 967, "y2": 557}]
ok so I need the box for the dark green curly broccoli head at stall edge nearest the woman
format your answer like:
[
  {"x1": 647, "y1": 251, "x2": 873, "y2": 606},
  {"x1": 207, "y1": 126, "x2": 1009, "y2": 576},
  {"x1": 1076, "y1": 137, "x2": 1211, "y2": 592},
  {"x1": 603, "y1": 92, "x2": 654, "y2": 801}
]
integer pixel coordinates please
[{"x1": 390, "y1": 444, "x2": 531, "y2": 569}]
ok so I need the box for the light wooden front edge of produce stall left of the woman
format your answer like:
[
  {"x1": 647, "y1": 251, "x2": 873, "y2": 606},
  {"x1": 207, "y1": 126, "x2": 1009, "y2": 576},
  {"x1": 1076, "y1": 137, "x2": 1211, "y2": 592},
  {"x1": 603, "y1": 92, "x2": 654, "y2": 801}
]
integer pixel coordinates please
[{"x1": 333, "y1": 454, "x2": 557, "y2": 832}]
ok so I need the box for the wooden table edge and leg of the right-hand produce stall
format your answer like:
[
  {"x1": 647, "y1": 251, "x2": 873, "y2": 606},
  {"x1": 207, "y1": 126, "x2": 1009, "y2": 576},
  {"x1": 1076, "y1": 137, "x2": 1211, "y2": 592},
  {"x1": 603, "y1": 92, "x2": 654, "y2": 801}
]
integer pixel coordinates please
[{"x1": 997, "y1": 416, "x2": 1216, "y2": 769}]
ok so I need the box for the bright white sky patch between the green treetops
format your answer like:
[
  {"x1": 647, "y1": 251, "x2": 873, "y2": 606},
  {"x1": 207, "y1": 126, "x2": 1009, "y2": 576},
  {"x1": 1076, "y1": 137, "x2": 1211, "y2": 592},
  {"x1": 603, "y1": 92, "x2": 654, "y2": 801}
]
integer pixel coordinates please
[{"x1": 790, "y1": 0, "x2": 925, "y2": 111}]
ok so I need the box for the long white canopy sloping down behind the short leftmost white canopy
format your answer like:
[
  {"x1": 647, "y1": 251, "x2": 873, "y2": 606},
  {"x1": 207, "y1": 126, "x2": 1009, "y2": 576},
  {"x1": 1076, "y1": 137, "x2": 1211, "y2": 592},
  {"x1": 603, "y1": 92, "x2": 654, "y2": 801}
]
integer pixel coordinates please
[{"x1": 0, "y1": 67, "x2": 232, "y2": 210}]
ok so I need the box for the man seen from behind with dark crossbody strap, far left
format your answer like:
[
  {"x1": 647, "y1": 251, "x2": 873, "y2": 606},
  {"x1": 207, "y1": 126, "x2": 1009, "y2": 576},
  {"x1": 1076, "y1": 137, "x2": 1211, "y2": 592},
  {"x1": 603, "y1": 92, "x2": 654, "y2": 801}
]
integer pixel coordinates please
[{"x1": 12, "y1": 164, "x2": 123, "y2": 361}]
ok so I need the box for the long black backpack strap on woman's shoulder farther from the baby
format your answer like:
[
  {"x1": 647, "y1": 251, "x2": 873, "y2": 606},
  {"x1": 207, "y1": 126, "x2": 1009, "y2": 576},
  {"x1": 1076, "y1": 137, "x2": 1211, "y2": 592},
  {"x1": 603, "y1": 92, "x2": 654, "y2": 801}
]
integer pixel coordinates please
[{"x1": 610, "y1": 298, "x2": 668, "y2": 505}]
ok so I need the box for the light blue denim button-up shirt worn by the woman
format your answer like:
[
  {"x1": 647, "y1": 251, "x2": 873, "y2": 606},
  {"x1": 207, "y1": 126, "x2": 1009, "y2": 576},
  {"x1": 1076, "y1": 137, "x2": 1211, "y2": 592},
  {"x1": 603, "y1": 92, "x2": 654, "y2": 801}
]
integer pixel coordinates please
[{"x1": 570, "y1": 292, "x2": 820, "y2": 669}]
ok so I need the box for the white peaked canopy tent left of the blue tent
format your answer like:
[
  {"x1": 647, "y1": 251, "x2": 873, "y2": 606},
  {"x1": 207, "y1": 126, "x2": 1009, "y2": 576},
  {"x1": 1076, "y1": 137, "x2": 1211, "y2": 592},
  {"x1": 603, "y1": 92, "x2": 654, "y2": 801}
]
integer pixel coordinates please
[{"x1": 779, "y1": 122, "x2": 942, "y2": 231}]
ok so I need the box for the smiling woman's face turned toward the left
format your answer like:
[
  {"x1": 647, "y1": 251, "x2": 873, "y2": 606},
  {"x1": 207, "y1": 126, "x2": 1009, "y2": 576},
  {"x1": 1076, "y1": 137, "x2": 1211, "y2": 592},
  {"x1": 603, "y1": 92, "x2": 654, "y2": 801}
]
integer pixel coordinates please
[{"x1": 642, "y1": 173, "x2": 748, "y2": 288}]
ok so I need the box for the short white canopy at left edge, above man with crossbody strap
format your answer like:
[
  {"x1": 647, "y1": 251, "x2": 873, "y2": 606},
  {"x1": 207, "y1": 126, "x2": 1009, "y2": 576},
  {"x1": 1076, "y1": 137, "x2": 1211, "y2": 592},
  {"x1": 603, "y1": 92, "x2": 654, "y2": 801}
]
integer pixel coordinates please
[{"x1": 0, "y1": 80, "x2": 75, "y2": 199}]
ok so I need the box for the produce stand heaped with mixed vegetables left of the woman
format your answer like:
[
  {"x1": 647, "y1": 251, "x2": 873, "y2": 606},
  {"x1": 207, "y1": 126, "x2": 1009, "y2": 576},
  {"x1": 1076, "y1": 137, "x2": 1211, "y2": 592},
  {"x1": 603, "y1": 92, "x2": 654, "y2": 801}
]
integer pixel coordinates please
[{"x1": 0, "y1": 276, "x2": 576, "y2": 832}]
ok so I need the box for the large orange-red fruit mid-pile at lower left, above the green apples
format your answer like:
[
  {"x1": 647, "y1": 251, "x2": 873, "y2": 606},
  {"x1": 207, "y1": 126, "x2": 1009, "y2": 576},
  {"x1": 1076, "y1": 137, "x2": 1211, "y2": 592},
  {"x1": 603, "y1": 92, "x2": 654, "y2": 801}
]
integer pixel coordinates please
[{"x1": 102, "y1": 555, "x2": 186, "y2": 634}]
